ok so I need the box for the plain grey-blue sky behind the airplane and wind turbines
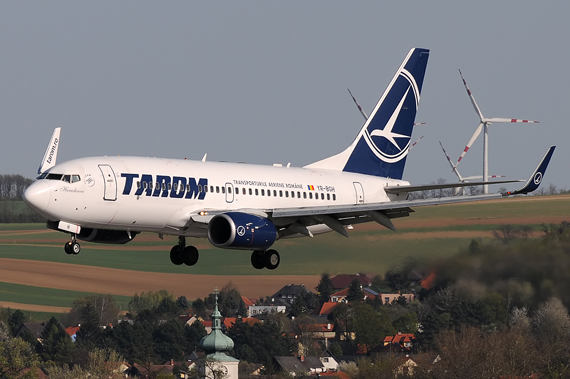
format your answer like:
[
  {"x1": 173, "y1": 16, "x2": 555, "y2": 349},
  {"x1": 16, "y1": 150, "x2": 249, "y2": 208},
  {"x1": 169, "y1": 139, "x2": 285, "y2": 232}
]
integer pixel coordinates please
[{"x1": 0, "y1": 1, "x2": 570, "y2": 191}]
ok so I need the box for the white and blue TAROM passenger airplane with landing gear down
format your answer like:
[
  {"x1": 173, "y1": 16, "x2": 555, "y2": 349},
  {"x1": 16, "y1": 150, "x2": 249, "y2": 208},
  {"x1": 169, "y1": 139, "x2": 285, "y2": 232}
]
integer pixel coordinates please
[{"x1": 24, "y1": 48, "x2": 554, "y2": 270}]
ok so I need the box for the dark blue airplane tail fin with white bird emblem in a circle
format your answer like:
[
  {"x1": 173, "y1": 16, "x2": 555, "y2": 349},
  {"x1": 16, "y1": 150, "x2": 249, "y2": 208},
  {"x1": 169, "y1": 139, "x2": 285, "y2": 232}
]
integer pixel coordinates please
[{"x1": 306, "y1": 48, "x2": 429, "y2": 179}]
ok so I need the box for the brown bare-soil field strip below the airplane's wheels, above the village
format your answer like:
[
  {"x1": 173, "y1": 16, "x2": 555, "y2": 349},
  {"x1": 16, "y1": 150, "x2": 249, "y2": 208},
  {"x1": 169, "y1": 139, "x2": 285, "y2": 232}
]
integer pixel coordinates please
[{"x1": 0, "y1": 258, "x2": 320, "y2": 299}]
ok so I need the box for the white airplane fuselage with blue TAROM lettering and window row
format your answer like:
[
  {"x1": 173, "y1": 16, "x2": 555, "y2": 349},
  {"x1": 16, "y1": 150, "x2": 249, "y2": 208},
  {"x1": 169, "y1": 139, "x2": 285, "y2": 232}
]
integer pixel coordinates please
[{"x1": 26, "y1": 157, "x2": 408, "y2": 237}]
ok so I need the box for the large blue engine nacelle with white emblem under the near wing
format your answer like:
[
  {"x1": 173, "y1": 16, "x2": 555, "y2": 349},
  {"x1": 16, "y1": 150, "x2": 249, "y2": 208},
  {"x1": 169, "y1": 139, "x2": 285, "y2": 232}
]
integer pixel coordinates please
[{"x1": 208, "y1": 212, "x2": 277, "y2": 250}]
